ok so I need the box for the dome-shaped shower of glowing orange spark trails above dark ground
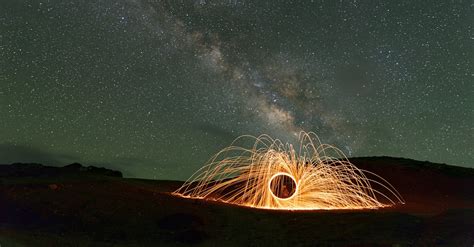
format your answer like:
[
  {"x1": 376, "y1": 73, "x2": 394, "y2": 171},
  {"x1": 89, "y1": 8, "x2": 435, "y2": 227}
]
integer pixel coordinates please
[{"x1": 173, "y1": 132, "x2": 404, "y2": 210}]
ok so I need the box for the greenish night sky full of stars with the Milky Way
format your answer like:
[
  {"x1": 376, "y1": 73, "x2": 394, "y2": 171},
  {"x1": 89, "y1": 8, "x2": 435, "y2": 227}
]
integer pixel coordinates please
[{"x1": 0, "y1": 0, "x2": 474, "y2": 179}]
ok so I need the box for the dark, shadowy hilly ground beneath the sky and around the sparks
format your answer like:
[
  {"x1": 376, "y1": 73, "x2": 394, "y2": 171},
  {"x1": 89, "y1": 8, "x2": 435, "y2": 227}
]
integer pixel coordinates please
[{"x1": 0, "y1": 157, "x2": 474, "y2": 247}]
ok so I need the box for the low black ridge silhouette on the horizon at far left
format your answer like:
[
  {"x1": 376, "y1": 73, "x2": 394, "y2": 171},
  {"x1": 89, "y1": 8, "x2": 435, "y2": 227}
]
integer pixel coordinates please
[{"x1": 0, "y1": 163, "x2": 122, "y2": 178}]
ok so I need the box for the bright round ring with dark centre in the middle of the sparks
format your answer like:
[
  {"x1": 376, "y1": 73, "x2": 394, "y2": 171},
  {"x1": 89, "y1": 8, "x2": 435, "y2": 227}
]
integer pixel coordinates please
[{"x1": 268, "y1": 172, "x2": 297, "y2": 200}]
